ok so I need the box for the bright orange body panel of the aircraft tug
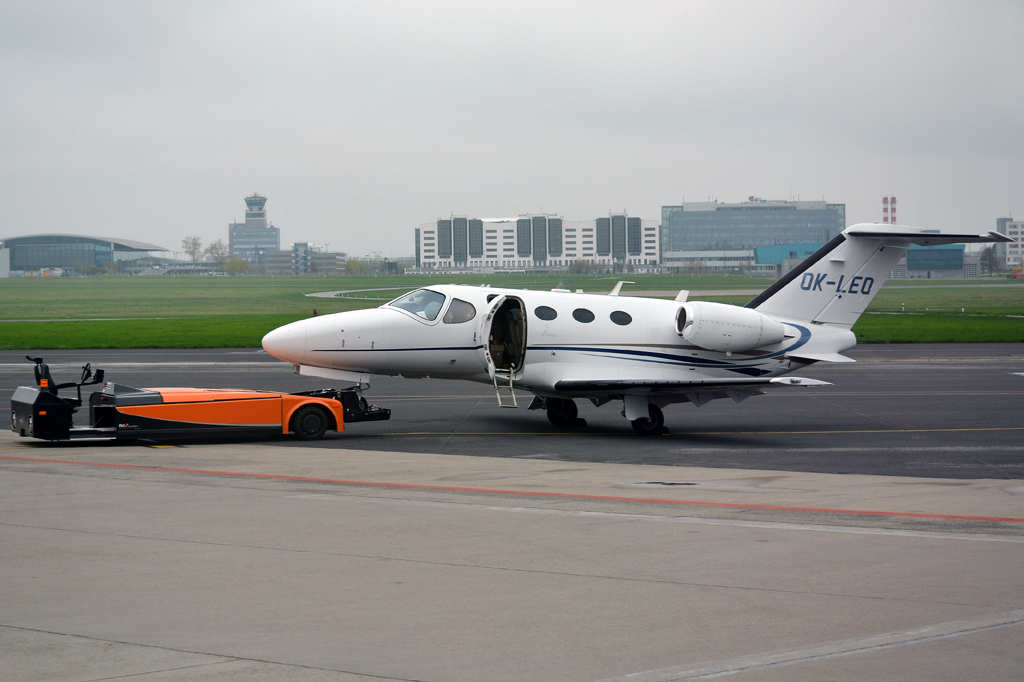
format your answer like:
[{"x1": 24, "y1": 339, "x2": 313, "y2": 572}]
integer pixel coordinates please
[{"x1": 118, "y1": 388, "x2": 345, "y2": 434}]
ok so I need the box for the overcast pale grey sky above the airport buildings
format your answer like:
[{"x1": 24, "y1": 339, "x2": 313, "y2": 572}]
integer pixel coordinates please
[{"x1": 0, "y1": 0, "x2": 1024, "y2": 256}]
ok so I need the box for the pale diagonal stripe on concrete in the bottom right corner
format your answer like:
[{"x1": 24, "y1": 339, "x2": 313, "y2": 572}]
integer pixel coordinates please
[{"x1": 599, "y1": 609, "x2": 1024, "y2": 682}]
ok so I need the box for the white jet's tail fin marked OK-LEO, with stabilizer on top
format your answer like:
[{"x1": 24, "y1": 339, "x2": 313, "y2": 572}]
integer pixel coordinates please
[{"x1": 746, "y1": 224, "x2": 1010, "y2": 329}]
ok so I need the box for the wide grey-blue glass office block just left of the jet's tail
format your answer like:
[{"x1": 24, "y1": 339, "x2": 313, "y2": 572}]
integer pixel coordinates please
[{"x1": 662, "y1": 198, "x2": 846, "y2": 252}]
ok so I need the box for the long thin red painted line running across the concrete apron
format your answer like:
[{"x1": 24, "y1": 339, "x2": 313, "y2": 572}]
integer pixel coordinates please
[{"x1": 0, "y1": 455, "x2": 1024, "y2": 523}]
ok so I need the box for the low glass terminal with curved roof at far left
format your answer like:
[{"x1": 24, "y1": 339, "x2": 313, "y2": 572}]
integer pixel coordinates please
[{"x1": 0, "y1": 235, "x2": 167, "y2": 278}]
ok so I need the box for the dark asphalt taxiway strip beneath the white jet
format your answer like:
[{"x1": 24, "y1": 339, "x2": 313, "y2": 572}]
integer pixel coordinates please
[{"x1": 0, "y1": 344, "x2": 1024, "y2": 479}]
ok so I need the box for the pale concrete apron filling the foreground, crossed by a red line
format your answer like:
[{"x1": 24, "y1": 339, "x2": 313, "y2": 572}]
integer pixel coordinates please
[{"x1": 0, "y1": 433, "x2": 1024, "y2": 681}]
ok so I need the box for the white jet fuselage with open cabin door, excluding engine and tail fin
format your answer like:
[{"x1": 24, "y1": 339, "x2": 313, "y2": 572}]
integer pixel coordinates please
[{"x1": 264, "y1": 285, "x2": 853, "y2": 399}]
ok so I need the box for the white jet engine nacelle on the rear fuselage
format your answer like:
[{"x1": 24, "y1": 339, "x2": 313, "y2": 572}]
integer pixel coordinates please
[{"x1": 676, "y1": 301, "x2": 785, "y2": 352}]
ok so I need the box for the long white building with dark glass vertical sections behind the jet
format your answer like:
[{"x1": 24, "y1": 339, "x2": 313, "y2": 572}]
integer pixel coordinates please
[{"x1": 416, "y1": 213, "x2": 659, "y2": 272}]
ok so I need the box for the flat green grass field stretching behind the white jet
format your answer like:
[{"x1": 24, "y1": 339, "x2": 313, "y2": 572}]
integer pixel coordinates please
[{"x1": 0, "y1": 274, "x2": 1024, "y2": 349}]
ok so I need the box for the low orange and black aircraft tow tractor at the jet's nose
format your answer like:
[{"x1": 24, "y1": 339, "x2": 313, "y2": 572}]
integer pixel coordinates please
[{"x1": 10, "y1": 357, "x2": 391, "y2": 440}]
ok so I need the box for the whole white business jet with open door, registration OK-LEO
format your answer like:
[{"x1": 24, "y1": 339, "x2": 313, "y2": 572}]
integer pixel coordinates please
[{"x1": 263, "y1": 224, "x2": 1011, "y2": 435}]
